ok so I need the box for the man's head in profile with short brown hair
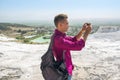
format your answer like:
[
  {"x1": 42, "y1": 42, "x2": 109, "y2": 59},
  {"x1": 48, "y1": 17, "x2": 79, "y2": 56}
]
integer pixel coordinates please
[{"x1": 54, "y1": 14, "x2": 68, "y2": 32}]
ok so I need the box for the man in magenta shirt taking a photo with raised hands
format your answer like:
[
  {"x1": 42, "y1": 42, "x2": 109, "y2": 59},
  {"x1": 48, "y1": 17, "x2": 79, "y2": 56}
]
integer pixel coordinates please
[{"x1": 53, "y1": 14, "x2": 91, "y2": 80}]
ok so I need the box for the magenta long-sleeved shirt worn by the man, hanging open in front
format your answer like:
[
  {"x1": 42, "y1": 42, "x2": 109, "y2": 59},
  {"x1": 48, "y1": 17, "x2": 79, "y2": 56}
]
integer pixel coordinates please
[{"x1": 53, "y1": 29, "x2": 85, "y2": 75}]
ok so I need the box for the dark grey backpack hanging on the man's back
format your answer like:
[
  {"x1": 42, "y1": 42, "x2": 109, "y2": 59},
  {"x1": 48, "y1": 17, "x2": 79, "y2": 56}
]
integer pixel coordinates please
[{"x1": 40, "y1": 35, "x2": 68, "y2": 80}]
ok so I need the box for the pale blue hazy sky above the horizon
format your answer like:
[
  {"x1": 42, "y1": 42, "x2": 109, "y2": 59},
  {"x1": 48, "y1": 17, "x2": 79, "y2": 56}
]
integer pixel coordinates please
[{"x1": 0, "y1": 0, "x2": 120, "y2": 22}]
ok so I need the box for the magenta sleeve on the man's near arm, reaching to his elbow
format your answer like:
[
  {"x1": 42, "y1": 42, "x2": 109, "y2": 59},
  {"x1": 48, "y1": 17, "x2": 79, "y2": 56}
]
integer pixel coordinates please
[{"x1": 55, "y1": 37, "x2": 85, "y2": 50}]
